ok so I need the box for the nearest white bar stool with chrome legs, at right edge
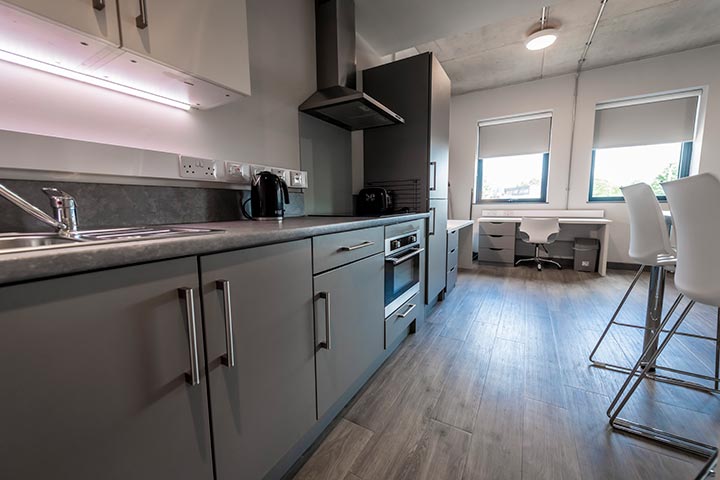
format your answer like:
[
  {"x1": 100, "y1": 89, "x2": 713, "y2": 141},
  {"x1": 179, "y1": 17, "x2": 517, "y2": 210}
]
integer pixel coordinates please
[{"x1": 607, "y1": 174, "x2": 720, "y2": 457}]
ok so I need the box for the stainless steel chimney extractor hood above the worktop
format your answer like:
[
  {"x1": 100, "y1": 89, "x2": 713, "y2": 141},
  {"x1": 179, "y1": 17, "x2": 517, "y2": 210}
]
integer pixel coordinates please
[{"x1": 300, "y1": 0, "x2": 404, "y2": 130}]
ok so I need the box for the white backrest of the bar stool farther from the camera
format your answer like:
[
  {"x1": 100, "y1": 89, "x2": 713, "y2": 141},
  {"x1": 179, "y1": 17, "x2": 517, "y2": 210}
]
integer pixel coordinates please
[{"x1": 620, "y1": 183, "x2": 675, "y2": 265}]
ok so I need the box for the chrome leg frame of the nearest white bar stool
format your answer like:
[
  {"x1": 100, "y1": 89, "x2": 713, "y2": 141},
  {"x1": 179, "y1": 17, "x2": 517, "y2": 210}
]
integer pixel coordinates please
[{"x1": 607, "y1": 301, "x2": 717, "y2": 457}]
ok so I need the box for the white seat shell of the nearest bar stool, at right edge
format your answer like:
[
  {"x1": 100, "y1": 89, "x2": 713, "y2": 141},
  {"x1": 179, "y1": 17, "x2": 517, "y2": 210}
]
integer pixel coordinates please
[{"x1": 663, "y1": 173, "x2": 720, "y2": 306}]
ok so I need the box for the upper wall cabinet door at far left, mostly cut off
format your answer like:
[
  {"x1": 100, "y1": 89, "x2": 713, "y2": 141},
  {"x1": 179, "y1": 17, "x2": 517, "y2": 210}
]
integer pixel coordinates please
[{"x1": 6, "y1": 0, "x2": 120, "y2": 46}]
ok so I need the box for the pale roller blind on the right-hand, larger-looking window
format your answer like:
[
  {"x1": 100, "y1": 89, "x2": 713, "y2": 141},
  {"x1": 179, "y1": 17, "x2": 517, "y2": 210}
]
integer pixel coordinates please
[{"x1": 593, "y1": 95, "x2": 699, "y2": 148}]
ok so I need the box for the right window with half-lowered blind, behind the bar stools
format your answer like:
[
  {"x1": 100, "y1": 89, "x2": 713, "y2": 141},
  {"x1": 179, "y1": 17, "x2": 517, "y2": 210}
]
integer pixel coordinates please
[{"x1": 588, "y1": 92, "x2": 699, "y2": 202}]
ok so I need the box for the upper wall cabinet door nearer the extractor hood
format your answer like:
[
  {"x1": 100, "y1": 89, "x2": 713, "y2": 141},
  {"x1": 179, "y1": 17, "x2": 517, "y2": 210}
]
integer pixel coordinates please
[{"x1": 119, "y1": 0, "x2": 250, "y2": 95}]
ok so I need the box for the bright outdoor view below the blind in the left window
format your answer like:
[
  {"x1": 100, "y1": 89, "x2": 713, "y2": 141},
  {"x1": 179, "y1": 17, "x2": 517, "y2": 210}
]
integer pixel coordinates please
[{"x1": 478, "y1": 153, "x2": 546, "y2": 201}]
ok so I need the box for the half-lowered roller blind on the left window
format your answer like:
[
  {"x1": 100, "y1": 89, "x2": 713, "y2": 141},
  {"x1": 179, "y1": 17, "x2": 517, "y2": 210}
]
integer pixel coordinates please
[{"x1": 478, "y1": 114, "x2": 552, "y2": 158}]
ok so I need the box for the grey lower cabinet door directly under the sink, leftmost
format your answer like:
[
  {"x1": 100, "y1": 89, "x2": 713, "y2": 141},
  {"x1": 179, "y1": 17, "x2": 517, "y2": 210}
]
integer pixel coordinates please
[{"x1": 0, "y1": 258, "x2": 213, "y2": 480}]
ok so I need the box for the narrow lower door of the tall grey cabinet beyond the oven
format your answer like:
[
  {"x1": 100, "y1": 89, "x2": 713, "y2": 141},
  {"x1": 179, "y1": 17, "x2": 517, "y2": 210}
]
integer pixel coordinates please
[{"x1": 425, "y1": 200, "x2": 447, "y2": 304}]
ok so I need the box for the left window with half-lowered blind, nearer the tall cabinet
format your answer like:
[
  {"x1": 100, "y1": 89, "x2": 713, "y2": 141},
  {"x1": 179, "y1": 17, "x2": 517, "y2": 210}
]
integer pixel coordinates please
[{"x1": 475, "y1": 113, "x2": 552, "y2": 203}]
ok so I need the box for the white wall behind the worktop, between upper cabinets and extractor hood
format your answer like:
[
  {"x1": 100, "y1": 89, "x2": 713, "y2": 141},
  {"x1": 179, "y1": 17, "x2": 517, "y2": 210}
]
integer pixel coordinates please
[{"x1": 0, "y1": 0, "x2": 315, "y2": 176}]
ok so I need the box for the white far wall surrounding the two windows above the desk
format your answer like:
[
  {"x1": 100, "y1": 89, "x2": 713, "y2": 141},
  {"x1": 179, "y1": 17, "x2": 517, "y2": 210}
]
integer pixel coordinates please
[{"x1": 450, "y1": 42, "x2": 720, "y2": 262}]
